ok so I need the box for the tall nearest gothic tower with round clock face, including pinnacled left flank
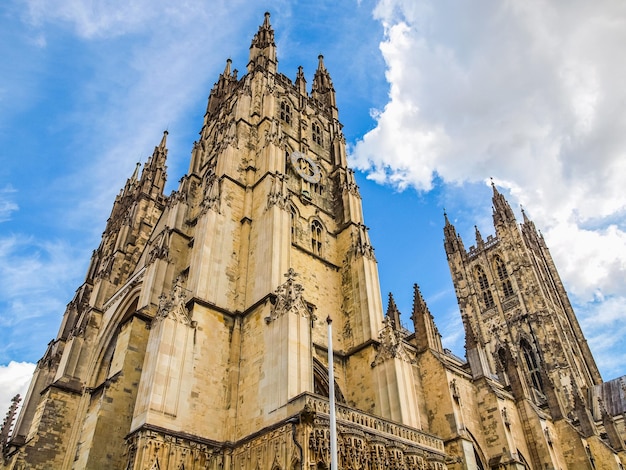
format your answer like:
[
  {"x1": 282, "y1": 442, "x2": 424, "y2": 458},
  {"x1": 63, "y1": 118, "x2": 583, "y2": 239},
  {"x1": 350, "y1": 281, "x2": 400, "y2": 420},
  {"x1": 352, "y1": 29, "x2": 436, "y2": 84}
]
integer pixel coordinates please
[{"x1": 4, "y1": 14, "x2": 445, "y2": 470}]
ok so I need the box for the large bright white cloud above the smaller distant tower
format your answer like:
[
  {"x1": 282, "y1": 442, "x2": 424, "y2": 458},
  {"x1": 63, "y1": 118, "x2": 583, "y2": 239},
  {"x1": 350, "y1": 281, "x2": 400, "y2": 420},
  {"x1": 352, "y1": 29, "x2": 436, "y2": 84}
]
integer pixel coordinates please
[{"x1": 352, "y1": 0, "x2": 626, "y2": 374}]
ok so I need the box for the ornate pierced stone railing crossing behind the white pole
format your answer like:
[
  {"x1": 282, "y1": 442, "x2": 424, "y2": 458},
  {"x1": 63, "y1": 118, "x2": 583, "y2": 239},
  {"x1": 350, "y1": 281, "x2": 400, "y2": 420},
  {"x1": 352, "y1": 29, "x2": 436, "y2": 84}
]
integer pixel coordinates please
[{"x1": 299, "y1": 394, "x2": 444, "y2": 453}]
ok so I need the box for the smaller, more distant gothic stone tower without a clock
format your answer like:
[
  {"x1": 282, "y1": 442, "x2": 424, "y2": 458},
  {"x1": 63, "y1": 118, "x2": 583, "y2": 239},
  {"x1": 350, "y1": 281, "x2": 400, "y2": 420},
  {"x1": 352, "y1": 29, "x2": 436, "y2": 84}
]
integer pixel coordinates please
[{"x1": 444, "y1": 186, "x2": 624, "y2": 468}]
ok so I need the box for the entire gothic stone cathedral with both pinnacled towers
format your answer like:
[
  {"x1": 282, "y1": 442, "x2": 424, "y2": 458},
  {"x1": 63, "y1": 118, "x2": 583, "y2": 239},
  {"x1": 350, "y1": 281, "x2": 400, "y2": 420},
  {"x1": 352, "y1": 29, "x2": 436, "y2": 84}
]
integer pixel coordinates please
[{"x1": 0, "y1": 13, "x2": 626, "y2": 470}]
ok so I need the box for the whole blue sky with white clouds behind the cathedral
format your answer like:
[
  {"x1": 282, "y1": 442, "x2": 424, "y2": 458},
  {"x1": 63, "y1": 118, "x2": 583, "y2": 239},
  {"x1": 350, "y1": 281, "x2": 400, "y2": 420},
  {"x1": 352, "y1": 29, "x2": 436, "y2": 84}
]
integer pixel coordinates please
[{"x1": 0, "y1": 0, "x2": 626, "y2": 413}]
